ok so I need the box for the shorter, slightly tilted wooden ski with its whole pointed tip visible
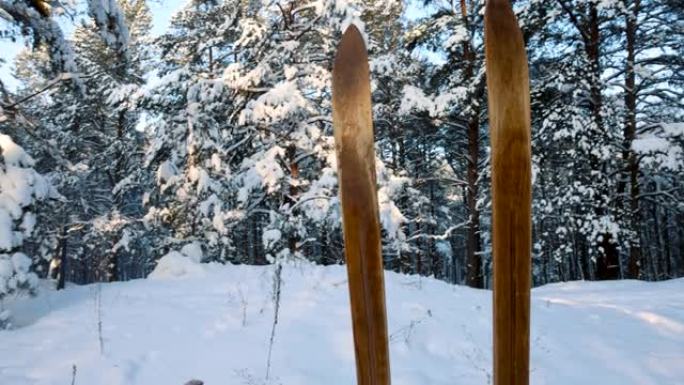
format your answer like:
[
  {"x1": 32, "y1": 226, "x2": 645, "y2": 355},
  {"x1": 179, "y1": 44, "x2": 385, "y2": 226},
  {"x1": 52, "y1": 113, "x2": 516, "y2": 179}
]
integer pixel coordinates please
[{"x1": 332, "y1": 25, "x2": 390, "y2": 385}]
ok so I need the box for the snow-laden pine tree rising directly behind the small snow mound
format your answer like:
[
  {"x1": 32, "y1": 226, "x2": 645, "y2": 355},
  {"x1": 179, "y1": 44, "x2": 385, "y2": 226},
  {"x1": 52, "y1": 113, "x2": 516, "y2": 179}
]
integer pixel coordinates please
[{"x1": 141, "y1": 1, "x2": 249, "y2": 260}]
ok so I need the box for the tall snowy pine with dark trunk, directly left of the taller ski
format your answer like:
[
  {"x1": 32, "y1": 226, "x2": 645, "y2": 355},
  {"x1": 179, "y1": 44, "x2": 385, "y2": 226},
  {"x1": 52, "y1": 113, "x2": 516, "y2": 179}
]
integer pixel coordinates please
[{"x1": 400, "y1": 0, "x2": 487, "y2": 287}]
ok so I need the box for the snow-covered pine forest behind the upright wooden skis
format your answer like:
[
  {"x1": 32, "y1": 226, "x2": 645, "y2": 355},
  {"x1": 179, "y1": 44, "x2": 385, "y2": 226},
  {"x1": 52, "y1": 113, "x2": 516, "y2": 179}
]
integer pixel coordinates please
[{"x1": 0, "y1": 0, "x2": 684, "y2": 298}]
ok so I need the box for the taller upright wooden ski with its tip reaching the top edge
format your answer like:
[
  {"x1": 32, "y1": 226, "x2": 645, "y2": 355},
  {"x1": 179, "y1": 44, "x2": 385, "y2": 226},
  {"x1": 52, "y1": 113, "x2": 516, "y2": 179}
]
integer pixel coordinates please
[{"x1": 485, "y1": 0, "x2": 532, "y2": 385}]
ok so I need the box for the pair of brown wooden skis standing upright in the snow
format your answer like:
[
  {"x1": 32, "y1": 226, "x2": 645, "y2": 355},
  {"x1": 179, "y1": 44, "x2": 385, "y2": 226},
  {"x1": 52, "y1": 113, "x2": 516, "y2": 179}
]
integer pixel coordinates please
[{"x1": 332, "y1": 0, "x2": 531, "y2": 385}]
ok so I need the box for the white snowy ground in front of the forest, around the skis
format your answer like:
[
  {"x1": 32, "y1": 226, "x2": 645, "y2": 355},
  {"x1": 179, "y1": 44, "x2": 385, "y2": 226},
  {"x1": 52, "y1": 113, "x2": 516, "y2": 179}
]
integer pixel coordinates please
[{"x1": 0, "y1": 265, "x2": 684, "y2": 385}]
